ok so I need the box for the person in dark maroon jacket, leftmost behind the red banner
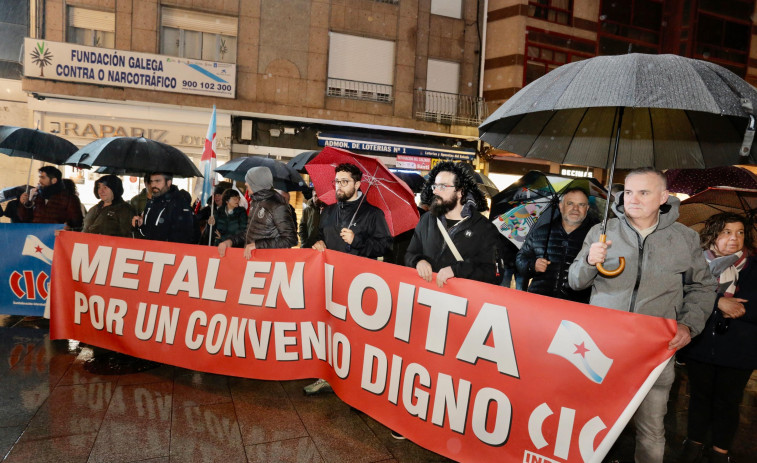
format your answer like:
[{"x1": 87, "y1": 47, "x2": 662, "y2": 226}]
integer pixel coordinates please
[{"x1": 17, "y1": 166, "x2": 84, "y2": 230}]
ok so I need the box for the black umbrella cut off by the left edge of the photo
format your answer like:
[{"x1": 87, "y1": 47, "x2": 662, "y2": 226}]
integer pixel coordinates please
[{"x1": 0, "y1": 125, "x2": 77, "y2": 164}]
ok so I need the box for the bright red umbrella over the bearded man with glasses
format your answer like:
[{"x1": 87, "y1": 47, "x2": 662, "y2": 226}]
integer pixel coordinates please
[{"x1": 305, "y1": 146, "x2": 419, "y2": 236}]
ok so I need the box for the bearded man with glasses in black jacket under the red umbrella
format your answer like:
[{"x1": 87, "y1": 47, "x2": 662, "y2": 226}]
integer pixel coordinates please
[{"x1": 303, "y1": 163, "x2": 392, "y2": 395}]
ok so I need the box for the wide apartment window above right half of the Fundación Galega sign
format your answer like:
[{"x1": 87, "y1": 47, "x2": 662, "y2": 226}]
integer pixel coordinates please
[{"x1": 160, "y1": 7, "x2": 237, "y2": 63}]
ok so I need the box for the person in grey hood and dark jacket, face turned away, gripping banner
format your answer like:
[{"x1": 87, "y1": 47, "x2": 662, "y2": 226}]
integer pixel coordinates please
[{"x1": 218, "y1": 166, "x2": 297, "y2": 259}]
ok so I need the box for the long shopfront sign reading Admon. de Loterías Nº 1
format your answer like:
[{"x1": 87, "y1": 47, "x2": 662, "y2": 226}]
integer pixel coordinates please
[{"x1": 318, "y1": 133, "x2": 476, "y2": 161}]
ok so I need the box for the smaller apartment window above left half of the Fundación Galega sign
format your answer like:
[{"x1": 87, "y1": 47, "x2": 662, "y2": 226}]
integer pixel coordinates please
[{"x1": 66, "y1": 6, "x2": 116, "y2": 48}]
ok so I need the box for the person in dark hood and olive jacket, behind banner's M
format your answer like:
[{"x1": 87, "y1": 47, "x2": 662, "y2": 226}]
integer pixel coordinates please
[{"x1": 82, "y1": 175, "x2": 135, "y2": 238}]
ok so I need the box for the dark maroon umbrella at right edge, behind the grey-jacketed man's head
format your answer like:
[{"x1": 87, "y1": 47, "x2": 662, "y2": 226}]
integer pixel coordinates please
[{"x1": 665, "y1": 166, "x2": 757, "y2": 195}]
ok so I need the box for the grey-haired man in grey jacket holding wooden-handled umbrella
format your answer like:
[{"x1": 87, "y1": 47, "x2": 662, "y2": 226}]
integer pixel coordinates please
[{"x1": 568, "y1": 168, "x2": 717, "y2": 463}]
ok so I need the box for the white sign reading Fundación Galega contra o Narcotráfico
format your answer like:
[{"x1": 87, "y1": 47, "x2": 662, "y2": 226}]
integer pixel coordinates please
[{"x1": 24, "y1": 38, "x2": 236, "y2": 98}]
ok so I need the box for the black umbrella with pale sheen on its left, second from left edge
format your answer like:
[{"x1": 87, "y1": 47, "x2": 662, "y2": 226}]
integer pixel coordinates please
[{"x1": 65, "y1": 137, "x2": 202, "y2": 177}]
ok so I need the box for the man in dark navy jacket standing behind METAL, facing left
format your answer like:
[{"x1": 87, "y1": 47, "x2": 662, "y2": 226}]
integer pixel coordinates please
[{"x1": 131, "y1": 173, "x2": 196, "y2": 243}]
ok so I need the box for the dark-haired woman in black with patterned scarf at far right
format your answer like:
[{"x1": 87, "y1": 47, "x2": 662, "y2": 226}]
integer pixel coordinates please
[{"x1": 679, "y1": 213, "x2": 757, "y2": 463}]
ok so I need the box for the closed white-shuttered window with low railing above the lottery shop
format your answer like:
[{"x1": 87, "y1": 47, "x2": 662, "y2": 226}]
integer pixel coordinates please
[{"x1": 327, "y1": 32, "x2": 395, "y2": 103}]
